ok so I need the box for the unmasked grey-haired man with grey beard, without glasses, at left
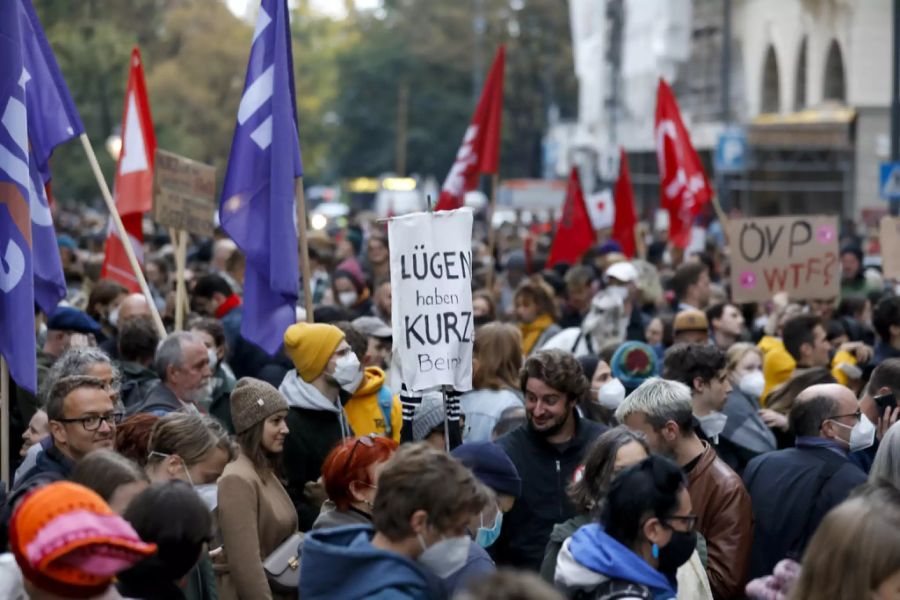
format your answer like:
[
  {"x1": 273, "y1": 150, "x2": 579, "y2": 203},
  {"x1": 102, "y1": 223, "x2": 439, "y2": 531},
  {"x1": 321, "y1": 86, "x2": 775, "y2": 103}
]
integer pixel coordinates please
[{"x1": 134, "y1": 331, "x2": 212, "y2": 416}]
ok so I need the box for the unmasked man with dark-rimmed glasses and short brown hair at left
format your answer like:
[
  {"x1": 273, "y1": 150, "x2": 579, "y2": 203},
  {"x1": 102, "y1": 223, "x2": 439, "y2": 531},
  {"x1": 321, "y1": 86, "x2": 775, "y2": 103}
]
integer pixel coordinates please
[{"x1": 10, "y1": 375, "x2": 122, "y2": 506}]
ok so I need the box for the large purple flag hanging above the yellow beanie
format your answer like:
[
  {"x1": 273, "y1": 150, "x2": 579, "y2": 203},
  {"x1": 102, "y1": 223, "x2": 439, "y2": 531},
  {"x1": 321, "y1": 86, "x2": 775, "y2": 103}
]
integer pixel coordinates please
[{"x1": 219, "y1": 0, "x2": 303, "y2": 354}]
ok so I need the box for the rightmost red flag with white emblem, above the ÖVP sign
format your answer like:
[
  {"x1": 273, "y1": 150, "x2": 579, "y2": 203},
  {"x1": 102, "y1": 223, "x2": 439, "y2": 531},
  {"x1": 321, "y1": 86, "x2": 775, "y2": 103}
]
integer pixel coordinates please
[{"x1": 656, "y1": 78, "x2": 712, "y2": 248}]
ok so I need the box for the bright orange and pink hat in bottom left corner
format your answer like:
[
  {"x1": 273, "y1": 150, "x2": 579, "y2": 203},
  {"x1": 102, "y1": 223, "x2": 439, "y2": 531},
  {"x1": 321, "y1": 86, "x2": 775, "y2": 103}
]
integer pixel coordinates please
[{"x1": 9, "y1": 481, "x2": 156, "y2": 598}]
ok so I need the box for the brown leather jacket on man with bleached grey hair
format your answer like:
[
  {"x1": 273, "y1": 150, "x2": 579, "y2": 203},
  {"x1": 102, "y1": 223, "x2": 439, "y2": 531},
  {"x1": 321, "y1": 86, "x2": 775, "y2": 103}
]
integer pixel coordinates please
[{"x1": 688, "y1": 442, "x2": 753, "y2": 600}]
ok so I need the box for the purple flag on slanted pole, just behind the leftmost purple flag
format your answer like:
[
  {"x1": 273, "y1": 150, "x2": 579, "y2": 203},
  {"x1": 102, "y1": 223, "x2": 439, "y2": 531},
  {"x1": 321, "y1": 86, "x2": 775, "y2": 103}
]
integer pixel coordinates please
[{"x1": 18, "y1": 0, "x2": 84, "y2": 315}]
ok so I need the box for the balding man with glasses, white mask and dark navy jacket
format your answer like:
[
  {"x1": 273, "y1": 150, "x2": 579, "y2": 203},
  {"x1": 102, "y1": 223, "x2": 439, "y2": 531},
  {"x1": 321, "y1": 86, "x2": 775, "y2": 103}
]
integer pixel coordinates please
[{"x1": 744, "y1": 383, "x2": 875, "y2": 577}]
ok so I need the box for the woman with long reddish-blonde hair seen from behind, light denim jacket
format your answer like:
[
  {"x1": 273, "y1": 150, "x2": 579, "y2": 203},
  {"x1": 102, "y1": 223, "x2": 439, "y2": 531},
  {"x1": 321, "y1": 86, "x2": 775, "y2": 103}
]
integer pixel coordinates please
[{"x1": 460, "y1": 323, "x2": 523, "y2": 443}]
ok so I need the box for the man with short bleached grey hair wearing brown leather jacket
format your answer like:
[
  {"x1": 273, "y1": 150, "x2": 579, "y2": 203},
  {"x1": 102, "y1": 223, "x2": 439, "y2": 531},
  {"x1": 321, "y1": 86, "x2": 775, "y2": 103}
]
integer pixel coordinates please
[{"x1": 616, "y1": 377, "x2": 753, "y2": 599}]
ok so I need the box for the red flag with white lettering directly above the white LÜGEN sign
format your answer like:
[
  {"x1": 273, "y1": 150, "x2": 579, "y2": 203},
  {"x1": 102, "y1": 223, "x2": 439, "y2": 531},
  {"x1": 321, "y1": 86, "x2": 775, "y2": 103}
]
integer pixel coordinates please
[{"x1": 435, "y1": 46, "x2": 506, "y2": 210}]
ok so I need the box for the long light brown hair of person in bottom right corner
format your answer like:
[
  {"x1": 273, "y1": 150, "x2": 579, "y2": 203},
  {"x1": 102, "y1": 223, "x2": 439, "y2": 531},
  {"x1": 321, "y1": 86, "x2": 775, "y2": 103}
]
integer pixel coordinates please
[{"x1": 789, "y1": 483, "x2": 900, "y2": 600}]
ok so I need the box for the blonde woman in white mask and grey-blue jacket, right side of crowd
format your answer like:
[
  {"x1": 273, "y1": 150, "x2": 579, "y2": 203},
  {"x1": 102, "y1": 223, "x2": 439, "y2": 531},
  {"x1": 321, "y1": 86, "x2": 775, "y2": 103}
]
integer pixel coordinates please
[{"x1": 721, "y1": 342, "x2": 778, "y2": 473}]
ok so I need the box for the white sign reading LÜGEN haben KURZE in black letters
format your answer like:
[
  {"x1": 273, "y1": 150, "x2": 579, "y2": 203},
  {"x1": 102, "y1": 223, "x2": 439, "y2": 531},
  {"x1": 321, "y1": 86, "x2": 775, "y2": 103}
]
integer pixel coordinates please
[{"x1": 388, "y1": 208, "x2": 475, "y2": 392}]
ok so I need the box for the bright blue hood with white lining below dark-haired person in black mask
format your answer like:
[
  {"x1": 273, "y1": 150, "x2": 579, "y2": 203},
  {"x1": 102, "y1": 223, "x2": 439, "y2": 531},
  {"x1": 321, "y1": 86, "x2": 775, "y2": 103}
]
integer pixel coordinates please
[{"x1": 555, "y1": 523, "x2": 675, "y2": 600}]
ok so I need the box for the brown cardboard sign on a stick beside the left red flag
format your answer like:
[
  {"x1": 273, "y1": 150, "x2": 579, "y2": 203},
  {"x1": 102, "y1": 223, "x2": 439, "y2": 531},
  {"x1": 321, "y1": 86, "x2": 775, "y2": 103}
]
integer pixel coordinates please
[{"x1": 153, "y1": 149, "x2": 216, "y2": 237}]
